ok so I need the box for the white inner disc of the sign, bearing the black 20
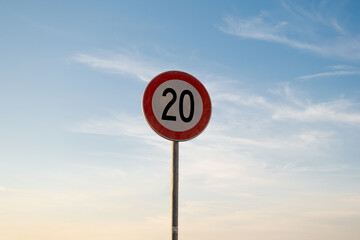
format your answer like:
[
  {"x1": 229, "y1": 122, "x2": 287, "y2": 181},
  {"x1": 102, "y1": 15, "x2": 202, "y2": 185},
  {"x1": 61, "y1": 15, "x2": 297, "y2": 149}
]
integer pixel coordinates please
[{"x1": 152, "y1": 80, "x2": 203, "y2": 132}]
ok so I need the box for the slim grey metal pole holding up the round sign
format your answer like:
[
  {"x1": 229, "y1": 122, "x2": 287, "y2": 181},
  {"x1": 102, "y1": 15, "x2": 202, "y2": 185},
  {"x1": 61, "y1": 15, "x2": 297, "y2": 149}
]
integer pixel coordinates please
[{"x1": 171, "y1": 141, "x2": 179, "y2": 240}]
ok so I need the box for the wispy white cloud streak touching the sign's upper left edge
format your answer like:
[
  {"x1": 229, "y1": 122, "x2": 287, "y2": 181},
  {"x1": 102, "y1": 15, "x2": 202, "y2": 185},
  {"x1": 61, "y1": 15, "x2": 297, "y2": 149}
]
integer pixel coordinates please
[{"x1": 71, "y1": 52, "x2": 169, "y2": 82}]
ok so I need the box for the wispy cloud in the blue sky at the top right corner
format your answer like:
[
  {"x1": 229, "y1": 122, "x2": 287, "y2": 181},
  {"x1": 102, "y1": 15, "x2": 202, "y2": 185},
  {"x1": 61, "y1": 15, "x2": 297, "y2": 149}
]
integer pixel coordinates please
[{"x1": 219, "y1": 4, "x2": 360, "y2": 60}]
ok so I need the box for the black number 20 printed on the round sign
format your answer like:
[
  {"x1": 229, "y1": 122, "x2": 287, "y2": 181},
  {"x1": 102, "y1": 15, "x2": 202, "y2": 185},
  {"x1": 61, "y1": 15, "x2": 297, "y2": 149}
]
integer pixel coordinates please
[{"x1": 161, "y1": 88, "x2": 194, "y2": 123}]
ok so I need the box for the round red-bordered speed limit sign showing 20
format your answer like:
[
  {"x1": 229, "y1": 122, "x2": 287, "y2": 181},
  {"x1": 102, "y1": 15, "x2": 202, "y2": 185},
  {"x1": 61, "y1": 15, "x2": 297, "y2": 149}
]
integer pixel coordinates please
[{"x1": 142, "y1": 71, "x2": 211, "y2": 141}]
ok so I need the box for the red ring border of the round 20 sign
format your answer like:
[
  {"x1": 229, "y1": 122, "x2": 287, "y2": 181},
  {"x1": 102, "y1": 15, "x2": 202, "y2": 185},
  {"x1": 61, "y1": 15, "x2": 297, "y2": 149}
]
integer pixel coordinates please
[{"x1": 142, "y1": 71, "x2": 211, "y2": 141}]
